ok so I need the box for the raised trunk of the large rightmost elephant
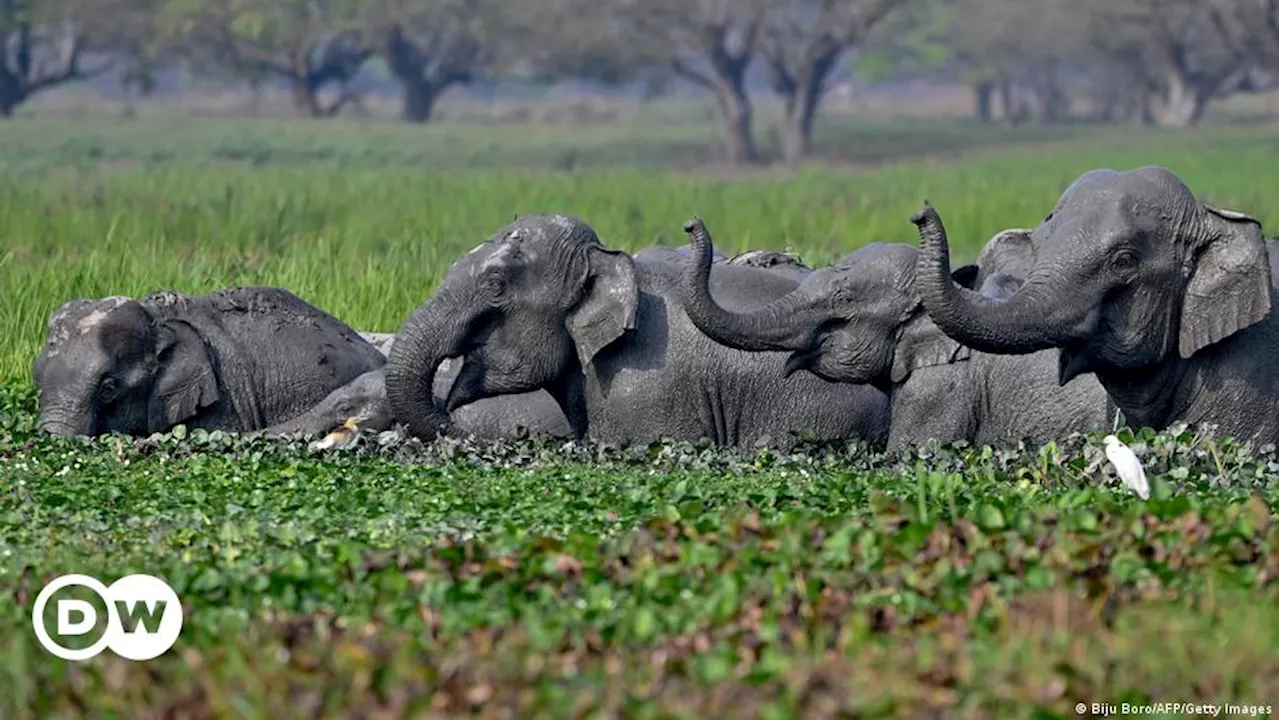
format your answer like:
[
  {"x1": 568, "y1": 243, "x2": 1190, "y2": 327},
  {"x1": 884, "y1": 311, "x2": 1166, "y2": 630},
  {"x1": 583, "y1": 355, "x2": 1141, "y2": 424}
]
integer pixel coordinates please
[{"x1": 911, "y1": 201, "x2": 1074, "y2": 355}]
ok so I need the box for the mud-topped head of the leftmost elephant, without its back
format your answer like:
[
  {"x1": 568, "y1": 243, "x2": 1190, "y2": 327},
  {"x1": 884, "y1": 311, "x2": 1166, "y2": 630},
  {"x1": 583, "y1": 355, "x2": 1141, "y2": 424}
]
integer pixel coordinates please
[{"x1": 33, "y1": 297, "x2": 219, "y2": 436}]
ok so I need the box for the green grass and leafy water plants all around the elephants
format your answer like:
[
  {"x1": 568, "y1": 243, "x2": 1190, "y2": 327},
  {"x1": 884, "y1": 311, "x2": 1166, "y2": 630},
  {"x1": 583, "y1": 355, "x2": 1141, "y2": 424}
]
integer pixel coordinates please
[{"x1": 0, "y1": 114, "x2": 1280, "y2": 717}]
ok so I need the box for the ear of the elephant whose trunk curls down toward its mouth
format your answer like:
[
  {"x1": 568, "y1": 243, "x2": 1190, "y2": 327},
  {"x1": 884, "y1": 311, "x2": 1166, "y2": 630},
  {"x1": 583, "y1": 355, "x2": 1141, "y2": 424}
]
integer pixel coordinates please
[{"x1": 566, "y1": 247, "x2": 640, "y2": 373}]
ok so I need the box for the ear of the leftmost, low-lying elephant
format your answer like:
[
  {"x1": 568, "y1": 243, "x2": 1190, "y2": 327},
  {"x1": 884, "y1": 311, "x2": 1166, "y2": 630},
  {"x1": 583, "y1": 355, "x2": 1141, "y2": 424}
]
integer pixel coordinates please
[{"x1": 152, "y1": 318, "x2": 218, "y2": 427}]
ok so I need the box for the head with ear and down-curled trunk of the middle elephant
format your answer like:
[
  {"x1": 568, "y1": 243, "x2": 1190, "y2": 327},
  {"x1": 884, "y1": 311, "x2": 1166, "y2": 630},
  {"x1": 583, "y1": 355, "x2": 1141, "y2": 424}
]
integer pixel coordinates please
[{"x1": 387, "y1": 215, "x2": 639, "y2": 437}]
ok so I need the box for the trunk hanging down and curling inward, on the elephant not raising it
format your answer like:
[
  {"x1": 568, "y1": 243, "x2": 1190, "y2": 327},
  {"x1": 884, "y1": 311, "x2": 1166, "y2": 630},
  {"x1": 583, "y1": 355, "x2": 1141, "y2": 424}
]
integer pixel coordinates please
[{"x1": 387, "y1": 292, "x2": 470, "y2": 439}]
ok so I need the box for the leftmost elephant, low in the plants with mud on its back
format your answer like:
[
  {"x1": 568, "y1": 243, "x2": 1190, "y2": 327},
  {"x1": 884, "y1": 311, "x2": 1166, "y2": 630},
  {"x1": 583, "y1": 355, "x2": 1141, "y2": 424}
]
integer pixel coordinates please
[{"x1": 33, "y1": 287, "x2": 387, "y2": 436}]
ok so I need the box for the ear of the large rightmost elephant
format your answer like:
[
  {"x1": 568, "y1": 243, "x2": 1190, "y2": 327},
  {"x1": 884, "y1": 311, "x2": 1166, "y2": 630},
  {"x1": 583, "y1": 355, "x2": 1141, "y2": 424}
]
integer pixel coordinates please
[{"x1": 1178, "y1": 205, "x2": 1271, "y2": 359}]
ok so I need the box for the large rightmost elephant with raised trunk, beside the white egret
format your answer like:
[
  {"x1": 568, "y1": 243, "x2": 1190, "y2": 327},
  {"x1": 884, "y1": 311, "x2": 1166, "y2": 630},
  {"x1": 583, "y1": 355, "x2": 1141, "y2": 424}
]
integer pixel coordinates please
[{"x1": 911, "y1": 165, "x2": 1280, "y2": 443}]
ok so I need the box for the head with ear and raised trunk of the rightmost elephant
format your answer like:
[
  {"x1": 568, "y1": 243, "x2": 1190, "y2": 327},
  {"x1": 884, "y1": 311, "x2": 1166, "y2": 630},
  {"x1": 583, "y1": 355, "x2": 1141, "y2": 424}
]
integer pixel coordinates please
[{"x1": 913, "y1": 167, "x2": 1271, "y2": 384}]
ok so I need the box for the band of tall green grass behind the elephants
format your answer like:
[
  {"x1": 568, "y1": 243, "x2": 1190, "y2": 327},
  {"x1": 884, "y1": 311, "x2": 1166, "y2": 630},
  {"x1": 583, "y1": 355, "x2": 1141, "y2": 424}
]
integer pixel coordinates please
[{"x1": 0, "y1": 123, "x2": 1280, "y2": 383}]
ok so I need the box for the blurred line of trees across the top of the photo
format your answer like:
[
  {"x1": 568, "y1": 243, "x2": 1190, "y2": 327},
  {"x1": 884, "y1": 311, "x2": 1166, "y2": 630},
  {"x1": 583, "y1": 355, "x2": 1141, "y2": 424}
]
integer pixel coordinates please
[{"x1": 0, "y1": 0, "x2": 1280, "y2": 163}]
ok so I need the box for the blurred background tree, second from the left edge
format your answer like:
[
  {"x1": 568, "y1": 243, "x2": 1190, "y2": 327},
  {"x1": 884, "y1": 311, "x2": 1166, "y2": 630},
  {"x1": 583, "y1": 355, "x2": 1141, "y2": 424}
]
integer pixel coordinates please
[{"x1": 163, "y1": 0, "x2": 374, "y2": 118}]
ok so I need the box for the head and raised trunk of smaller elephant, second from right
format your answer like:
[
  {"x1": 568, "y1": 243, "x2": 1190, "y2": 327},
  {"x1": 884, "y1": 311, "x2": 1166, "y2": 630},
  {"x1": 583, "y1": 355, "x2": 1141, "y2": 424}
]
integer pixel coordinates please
[{"x1": 684, "y1": 215, "x2": 1004, "y2": 389}]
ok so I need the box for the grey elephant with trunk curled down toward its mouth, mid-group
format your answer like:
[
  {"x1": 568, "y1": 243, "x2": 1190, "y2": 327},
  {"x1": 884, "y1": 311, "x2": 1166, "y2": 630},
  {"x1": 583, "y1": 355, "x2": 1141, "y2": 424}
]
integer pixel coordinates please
[{"x1": 387, "y1": 214, "x2": 888, "y2": 447}]
